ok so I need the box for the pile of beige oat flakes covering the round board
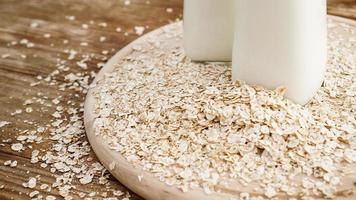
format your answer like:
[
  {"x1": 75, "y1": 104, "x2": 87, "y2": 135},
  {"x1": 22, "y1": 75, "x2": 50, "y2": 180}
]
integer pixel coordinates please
[{"x1": 93, "y1": 21, "x2": 356, "y2": 198}]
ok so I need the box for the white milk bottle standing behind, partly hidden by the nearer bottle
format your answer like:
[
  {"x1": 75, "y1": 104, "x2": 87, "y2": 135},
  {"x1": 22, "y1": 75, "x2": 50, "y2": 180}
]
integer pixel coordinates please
[{"x1": 183, "y1": 0, "x2": 235, "y2": 61}]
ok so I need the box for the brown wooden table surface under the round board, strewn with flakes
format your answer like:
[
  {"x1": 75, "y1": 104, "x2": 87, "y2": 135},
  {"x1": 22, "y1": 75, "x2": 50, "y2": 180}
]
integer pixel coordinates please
[{"x1": 0, "y1": 0, "x2": 356, "y2": 199}]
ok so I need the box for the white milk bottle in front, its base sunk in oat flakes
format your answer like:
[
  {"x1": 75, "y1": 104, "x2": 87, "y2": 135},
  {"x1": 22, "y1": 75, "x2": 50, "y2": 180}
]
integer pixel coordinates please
[{"x1": 232, "y1": 0, "x2": 327, "y2": 104}]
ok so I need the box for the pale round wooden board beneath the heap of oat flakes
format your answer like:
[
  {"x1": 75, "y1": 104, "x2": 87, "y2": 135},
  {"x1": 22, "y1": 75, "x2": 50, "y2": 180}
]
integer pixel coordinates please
[{"x1": 84, "y1": 16, "x2": 356, "y2": 200}]
